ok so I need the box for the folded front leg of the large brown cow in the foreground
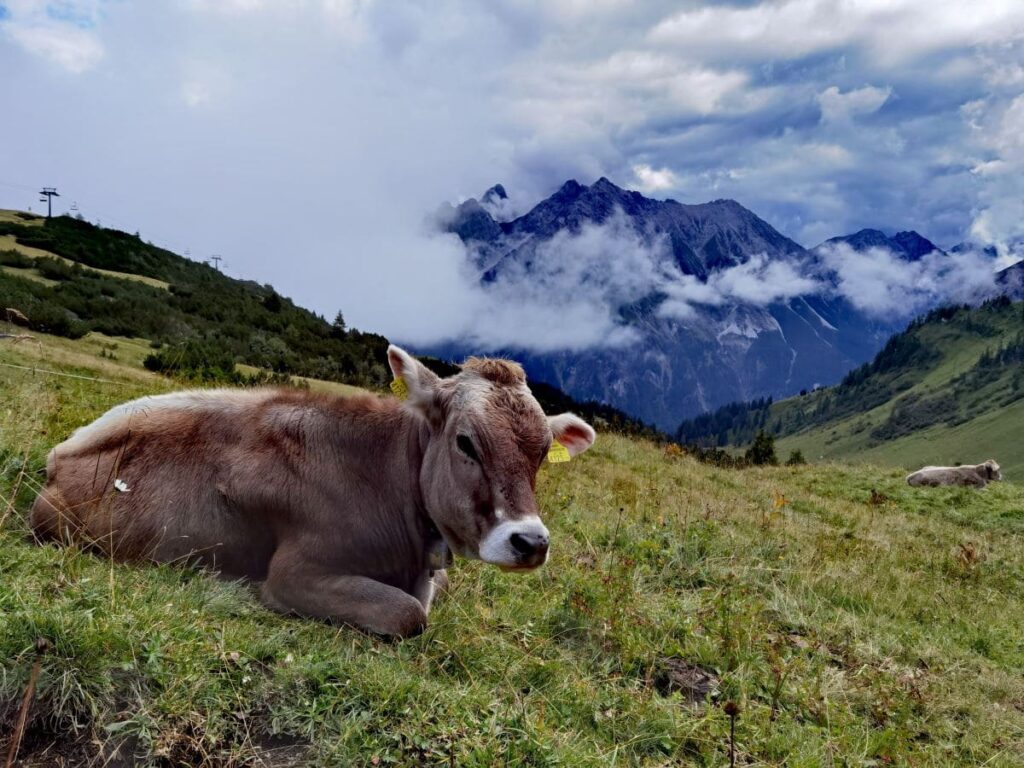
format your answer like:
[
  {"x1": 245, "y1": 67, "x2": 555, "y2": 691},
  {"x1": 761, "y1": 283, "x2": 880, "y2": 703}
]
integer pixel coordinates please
[{"x1": 262, "y1": 552, "x2": 427, "y2": 637}]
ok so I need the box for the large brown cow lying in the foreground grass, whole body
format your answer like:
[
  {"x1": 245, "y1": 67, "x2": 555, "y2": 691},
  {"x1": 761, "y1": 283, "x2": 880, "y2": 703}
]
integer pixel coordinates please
[{"x1": 32, "y1": 346, "x2": 595, "y2": 636}]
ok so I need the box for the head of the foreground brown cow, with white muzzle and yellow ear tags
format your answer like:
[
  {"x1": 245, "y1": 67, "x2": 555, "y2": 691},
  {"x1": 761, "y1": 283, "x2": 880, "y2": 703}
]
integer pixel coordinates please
[{"x1": 387, "y1": 345, "x2": 595, "y2": 570}]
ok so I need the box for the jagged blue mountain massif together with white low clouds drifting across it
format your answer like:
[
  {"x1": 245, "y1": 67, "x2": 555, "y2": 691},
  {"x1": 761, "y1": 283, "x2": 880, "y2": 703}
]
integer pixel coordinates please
[{"x1": 414, "y1": 178, "x2": 1019, "y2": 434}]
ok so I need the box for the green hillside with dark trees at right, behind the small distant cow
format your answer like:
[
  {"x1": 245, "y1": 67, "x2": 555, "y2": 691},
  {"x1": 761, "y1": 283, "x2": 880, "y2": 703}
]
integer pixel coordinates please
[{"x1": 676, "y1": 296, "x2": 1024, "y2": 479}]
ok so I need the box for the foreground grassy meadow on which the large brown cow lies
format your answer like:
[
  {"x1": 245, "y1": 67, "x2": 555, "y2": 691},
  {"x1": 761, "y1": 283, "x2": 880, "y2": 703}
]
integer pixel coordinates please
[{"x1": 0, "y1": 338, "x2": 1024, "y2": 766}]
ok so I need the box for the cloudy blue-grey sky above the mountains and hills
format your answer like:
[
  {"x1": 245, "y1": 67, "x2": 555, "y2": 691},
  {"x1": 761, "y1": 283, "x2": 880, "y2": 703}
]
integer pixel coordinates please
[{"x1": 0, "y1": 0, "x2": 1024, "y2": 336}]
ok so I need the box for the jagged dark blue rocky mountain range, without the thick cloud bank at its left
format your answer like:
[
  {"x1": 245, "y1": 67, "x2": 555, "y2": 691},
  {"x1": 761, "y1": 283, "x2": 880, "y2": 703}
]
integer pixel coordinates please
[{"x1": 421, "y1": 178, "x2": 1024, "y2": 430}]
